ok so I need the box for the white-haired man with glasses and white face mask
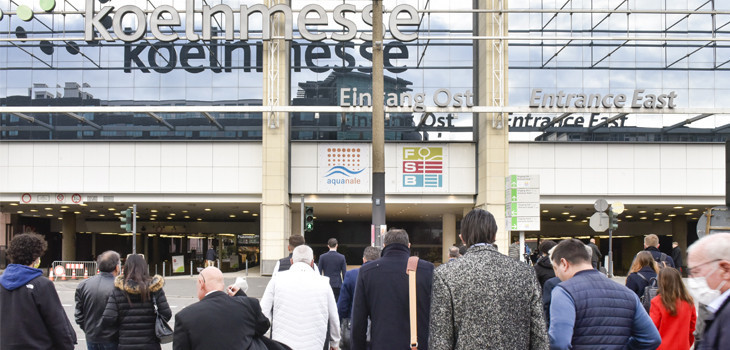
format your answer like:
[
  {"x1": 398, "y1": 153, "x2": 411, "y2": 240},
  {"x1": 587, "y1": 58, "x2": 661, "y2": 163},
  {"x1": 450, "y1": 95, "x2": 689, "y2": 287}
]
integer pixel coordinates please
[{"x1": 687, "y1": 233, "x2": 730, "y2": 350}]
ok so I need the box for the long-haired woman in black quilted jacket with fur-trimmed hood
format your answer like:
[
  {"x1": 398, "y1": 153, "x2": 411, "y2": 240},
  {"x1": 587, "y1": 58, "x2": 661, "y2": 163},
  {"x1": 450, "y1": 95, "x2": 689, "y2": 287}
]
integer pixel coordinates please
[{"x1": 103, "y1": 254, "x2": 172, "y2": 350}]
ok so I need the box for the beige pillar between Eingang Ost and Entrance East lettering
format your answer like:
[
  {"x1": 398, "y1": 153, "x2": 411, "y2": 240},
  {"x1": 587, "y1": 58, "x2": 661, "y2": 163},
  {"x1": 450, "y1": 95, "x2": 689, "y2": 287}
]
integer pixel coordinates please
[{"x1": 474, "y1": 0, "x2": 510, "y2": 254}]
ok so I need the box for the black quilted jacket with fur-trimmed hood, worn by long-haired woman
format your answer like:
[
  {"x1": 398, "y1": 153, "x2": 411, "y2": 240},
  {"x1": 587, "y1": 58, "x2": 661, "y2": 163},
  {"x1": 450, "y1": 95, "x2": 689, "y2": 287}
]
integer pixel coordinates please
[{"x1": 102, "y1": 275, "x2": 172, "y2": 350}]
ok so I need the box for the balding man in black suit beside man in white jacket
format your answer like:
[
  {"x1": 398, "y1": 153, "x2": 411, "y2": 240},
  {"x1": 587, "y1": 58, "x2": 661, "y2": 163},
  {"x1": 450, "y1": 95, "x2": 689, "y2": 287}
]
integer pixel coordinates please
[{"x1": 173, "y1": 267, "x2": 269, "y2": 350}]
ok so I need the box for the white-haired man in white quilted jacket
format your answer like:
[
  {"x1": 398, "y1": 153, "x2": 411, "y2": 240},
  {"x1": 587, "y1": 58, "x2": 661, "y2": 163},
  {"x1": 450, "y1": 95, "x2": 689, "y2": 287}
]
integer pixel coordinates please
[{"x1": 261, "y1": 245, "x2": 340, "y2": 350}]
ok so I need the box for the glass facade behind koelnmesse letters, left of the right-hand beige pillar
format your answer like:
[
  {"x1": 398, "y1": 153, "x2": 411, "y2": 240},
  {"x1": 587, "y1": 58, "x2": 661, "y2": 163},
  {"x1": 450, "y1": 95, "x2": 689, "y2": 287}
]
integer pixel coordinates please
[{"x1": 0, "y1": 0, "x2": 474, "y2": 141}]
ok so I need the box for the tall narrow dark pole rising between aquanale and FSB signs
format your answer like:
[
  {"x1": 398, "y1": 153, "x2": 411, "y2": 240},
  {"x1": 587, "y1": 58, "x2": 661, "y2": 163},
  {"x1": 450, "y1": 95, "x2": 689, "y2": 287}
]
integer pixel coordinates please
[{"x1": 371, "y1": 0, "x2": 385, "y2": 247}]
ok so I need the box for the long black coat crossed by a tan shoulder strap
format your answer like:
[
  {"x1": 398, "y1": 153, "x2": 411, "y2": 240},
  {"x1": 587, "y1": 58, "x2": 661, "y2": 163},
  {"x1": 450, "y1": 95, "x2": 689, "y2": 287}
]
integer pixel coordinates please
[{"x1": 351, "y1": 244, "x2": 434, "y2": 350}]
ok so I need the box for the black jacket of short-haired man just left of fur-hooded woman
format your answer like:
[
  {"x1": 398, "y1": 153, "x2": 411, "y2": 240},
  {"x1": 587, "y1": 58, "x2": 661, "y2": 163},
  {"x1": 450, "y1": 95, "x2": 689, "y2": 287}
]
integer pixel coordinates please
[{"x1": 74, "y1": 272, "x2": 119, "y2": 343}]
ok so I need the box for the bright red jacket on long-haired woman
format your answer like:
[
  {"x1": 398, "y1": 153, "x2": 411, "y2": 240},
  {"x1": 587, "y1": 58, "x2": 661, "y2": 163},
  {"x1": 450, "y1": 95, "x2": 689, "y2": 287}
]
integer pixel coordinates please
[{"x1": 649, "y1": 295, "x2": 697, "y2": 350}]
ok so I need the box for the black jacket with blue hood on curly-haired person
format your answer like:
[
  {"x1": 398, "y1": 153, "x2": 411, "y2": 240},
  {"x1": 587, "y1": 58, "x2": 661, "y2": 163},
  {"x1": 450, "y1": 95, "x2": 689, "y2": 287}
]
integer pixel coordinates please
[{"x1": 0, "y1": 264, "x2": 76, "y2": 350}]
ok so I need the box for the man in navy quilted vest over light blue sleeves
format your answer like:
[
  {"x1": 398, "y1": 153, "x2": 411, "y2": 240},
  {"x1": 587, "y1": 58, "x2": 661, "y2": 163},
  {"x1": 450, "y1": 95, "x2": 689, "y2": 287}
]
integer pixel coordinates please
[{"x1": 548, "y1": 239, "x2": 662, "y2": 349}]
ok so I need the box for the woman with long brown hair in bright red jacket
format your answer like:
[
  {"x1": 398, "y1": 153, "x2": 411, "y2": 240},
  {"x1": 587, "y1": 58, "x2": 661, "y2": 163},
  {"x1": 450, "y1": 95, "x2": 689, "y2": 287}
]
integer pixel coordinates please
[{"x1": 649, "y1": 269, "x2": 697, "y2": 350}]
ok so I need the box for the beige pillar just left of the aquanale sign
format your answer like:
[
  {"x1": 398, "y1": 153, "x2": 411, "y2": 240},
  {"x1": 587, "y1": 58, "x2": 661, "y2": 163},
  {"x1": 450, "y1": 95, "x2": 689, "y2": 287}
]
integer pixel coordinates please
[{"x1": 260, "y1": 0, "x2": 292, "y2": 274}]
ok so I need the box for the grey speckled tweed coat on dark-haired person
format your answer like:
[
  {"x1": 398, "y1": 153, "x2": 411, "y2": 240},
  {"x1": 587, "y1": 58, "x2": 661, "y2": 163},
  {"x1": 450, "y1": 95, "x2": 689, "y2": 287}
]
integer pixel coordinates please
[{"x1": 429, "y1": 246, "x2": 549, "y2": 350}]
